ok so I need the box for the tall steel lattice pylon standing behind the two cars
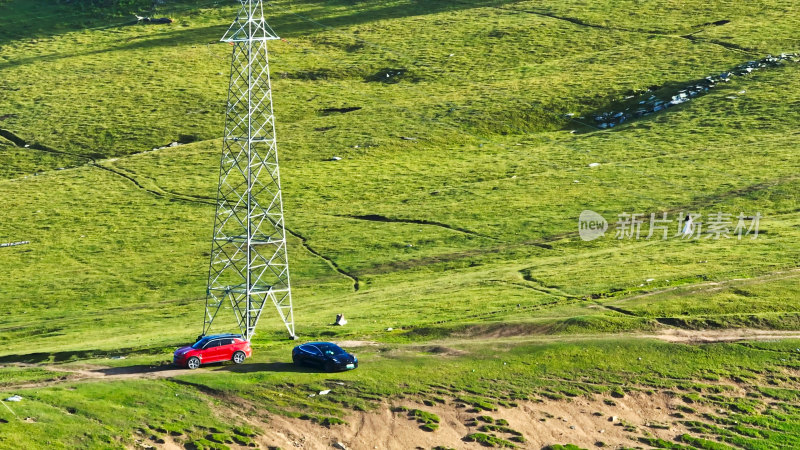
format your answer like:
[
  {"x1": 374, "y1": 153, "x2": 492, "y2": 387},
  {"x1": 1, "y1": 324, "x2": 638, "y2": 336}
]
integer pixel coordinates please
[{"x1": 203, "y1": 0, "x2": 295, "y2": 341}]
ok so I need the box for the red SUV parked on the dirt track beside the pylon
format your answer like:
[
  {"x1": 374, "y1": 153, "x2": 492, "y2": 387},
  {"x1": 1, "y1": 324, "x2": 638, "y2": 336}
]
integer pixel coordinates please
[{"x1": 172, "y1": 334, "x2": 253, "y2": 369}]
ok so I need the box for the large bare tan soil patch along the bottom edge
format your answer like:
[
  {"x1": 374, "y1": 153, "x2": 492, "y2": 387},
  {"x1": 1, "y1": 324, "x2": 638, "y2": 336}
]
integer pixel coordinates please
[{"x1": 248, "y1": 392, "x2": 712, "y2": 450}]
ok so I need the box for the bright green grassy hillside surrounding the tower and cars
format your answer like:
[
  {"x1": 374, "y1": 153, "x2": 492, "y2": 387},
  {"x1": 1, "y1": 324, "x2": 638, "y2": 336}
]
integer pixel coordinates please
[{"x1": 0, "y1": 0, "x2": 800, "y2": 449}]
